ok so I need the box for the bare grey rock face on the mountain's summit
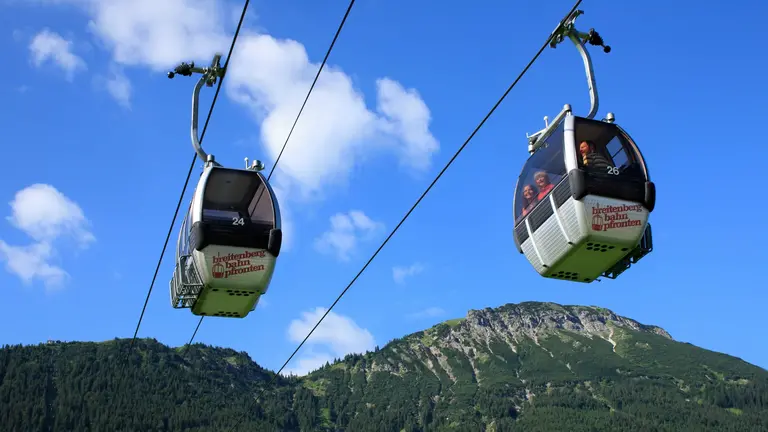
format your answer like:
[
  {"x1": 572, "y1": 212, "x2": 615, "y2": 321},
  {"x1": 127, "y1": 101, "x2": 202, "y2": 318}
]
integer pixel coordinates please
[{"x1": 364, "y1": 302, "x2": 672, "y2": 385}]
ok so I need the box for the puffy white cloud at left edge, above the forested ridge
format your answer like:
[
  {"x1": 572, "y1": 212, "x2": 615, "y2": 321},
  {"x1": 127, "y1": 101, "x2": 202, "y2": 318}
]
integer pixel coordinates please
[{"x1": 0, "y1": 184, "x2": 96, "y2": 289}]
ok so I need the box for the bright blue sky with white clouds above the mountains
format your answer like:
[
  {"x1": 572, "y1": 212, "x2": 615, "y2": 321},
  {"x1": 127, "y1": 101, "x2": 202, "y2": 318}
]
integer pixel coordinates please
[{"x1": 0, "y1": 0, "x2": 768, "y2": 371}]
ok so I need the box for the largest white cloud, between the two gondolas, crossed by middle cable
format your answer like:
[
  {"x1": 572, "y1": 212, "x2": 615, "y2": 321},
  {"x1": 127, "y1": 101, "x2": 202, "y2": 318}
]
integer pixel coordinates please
[{"x1": 225, "y1": 34, "x2": 439, "y2": 197}]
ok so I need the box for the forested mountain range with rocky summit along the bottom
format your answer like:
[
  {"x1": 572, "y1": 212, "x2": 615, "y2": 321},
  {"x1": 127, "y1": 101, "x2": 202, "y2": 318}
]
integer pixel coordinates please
[{"x1": 0, "y1": 302, "x2": 768, "y2": 432}]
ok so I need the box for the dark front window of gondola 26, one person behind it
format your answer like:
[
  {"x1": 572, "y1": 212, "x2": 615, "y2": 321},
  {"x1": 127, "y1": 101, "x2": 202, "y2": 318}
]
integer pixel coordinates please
[{"x1": 574, "y1": 117, "x2": 645, "y2": 181}]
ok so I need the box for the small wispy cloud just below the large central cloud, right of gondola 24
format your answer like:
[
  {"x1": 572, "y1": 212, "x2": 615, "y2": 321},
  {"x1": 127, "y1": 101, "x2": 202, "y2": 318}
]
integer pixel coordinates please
[{"x1": 315, "y1": 210, "x2": 384, "y2": 261}]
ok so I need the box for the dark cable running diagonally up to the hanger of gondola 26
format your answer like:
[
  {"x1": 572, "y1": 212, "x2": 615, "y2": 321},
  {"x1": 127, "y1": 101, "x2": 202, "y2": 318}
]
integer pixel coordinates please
[{"x1": 230, "y1": 0, "x2": 583, "y2": 431}]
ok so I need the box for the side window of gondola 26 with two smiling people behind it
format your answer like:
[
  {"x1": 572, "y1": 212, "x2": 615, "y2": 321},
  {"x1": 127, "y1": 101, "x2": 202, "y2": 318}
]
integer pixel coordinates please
[{"x1": 515, "y1": 122, "x2": 566, "y2": 224}]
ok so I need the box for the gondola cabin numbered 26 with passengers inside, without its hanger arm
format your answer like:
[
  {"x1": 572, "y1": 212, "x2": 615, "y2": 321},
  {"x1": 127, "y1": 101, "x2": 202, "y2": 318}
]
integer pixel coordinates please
[{"x1": 513, "y1": 106, "x2": 656, "y2": 283}]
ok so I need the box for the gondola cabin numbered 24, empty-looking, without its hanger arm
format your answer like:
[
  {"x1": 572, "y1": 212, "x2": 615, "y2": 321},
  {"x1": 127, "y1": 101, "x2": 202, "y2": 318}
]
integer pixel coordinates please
[{"x1": 170, "y1": 162, "x2": 282, "y2": 318}]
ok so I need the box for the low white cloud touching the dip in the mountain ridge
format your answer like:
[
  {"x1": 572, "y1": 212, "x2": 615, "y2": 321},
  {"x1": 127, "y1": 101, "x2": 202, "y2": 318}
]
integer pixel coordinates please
[{"x1": 284, "y1": 307, "x2": 376, "y2": 375}]
